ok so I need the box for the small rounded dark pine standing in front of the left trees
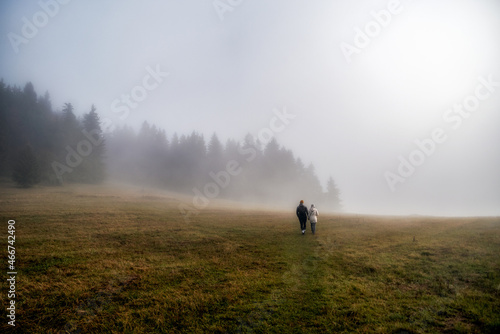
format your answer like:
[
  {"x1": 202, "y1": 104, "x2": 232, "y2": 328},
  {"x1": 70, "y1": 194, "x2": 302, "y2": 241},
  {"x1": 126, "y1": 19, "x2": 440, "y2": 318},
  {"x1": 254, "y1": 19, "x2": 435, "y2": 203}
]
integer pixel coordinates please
[{"x1": 12, "y1": 145, "x2": 40, "y2": 188}]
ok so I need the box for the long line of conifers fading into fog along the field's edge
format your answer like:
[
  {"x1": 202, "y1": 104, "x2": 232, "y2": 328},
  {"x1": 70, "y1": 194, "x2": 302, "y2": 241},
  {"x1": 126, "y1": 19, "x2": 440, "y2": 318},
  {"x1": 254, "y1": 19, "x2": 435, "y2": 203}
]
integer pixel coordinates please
[{"x1": 0, "y1": 81, "x2": 340, "y2": 210}]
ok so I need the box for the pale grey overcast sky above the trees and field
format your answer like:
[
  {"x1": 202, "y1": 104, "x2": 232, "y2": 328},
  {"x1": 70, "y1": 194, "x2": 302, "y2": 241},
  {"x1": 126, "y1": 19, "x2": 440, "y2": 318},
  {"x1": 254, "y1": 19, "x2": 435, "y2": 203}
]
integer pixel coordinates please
[{"x1": 0, "y1": 0, "x2": 500, "y2": 215}]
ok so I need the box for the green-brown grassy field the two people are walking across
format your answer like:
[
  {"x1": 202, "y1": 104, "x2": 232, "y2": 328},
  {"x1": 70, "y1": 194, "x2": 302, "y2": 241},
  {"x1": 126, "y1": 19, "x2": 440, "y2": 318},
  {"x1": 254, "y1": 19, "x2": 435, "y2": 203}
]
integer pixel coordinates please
[{"x1": 0, "y1": 185, "x2": 500, "y2": 333}]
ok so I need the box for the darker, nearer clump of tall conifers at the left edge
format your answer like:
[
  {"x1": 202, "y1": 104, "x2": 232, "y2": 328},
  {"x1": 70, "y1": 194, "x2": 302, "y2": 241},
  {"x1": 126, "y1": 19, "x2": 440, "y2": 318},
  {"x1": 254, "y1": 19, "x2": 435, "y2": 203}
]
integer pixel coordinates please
[{"x1": 0, "y1": 81, "x2": 104, "y2": 184}]
